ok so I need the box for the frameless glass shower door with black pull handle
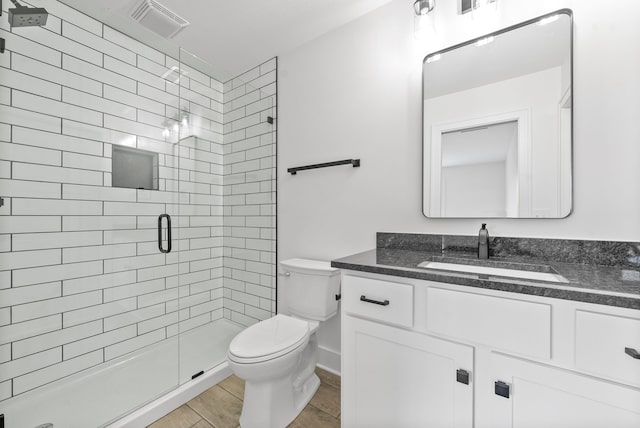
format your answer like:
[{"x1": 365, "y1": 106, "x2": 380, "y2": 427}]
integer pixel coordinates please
[{"x1": 0, "y1": 7, "x2": 188, "y2": 428}]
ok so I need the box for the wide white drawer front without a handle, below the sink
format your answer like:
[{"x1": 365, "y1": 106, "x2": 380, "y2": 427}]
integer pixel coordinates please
[{"x1": 427, "y1": 287, "x2": 551, "y2": 359}]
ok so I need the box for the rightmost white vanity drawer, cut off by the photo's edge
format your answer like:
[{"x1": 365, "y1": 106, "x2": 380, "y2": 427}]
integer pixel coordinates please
[{"x1": 576, "y1": 311, "x2": 640, "y2": 385}]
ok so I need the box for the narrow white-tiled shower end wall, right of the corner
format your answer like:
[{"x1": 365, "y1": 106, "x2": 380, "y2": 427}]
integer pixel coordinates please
[{"x1": 224, "y1": 58, "x2": 277, "y2": 325}]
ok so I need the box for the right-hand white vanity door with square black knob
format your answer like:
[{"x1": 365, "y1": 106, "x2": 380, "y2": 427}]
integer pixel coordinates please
[{"x1": 488, "y1": 355, "x2": 640, "y2": 428}]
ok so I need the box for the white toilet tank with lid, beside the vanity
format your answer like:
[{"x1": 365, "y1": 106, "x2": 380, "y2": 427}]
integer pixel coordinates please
[{"x1": 280, "y1": 259, "x2": 340, "y2": 321}]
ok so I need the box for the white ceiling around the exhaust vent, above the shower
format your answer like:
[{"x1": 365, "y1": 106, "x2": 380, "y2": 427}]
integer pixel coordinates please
[{"x1": 61, "y1": 0, "x2": 391, "y2": 82}]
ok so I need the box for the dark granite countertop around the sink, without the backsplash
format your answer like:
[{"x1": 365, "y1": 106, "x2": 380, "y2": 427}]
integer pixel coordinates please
[{"x1": 331, "y1": 248, "x2": 640, "y2": 310}]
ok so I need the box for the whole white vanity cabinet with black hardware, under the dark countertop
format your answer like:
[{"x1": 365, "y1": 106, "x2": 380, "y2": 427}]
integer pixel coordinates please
[{"x1": 342, "y1": 271, "x2": 640, "y2": 428}]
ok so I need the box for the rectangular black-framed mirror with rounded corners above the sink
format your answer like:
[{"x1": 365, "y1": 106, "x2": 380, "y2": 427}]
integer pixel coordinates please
[{"x1": 422, "y1": 9, "x2": 572, "y2": 218}]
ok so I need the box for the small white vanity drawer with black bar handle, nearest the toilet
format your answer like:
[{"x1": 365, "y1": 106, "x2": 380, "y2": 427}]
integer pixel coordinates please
[{"x1": 342, "y1": 275, "x2": 413, "y2": 327}]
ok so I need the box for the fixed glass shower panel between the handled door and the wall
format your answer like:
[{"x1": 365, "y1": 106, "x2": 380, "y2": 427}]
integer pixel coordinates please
[{"x1": 174, "y1": 49, "x2": 276, "y2": 392}]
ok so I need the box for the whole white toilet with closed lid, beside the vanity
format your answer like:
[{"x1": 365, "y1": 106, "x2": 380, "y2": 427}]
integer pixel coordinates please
[{"x1": 227, "y1": 259, "x2": 340, "y2": 428}]
